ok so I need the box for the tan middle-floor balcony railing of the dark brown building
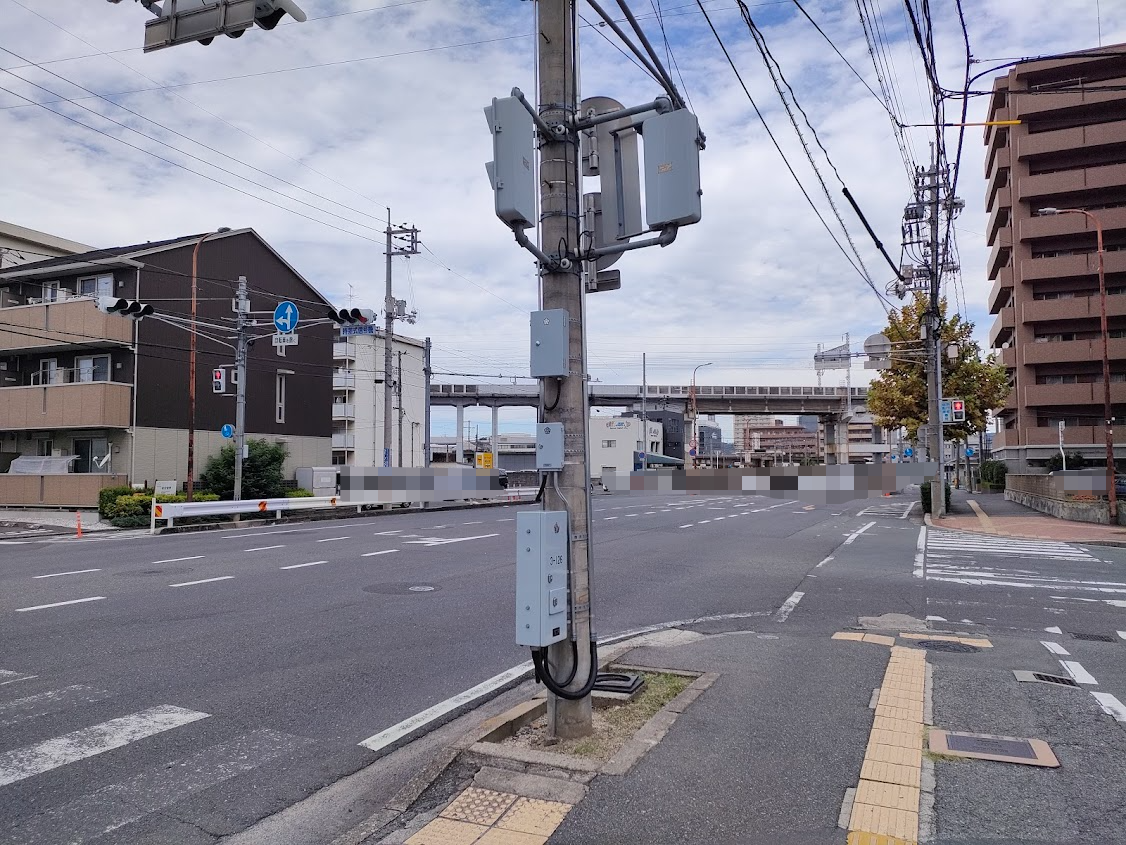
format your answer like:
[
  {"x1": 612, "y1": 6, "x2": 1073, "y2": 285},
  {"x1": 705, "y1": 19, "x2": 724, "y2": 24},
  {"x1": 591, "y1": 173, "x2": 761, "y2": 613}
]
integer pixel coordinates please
[{"x1": 0, "y1": 382, "x2": 133, "y2": 430}]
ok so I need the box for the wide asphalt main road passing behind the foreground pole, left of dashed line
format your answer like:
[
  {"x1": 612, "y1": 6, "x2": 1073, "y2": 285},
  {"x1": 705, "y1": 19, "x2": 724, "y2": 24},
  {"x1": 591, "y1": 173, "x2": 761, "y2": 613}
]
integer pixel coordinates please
[{"x1": 0, "y1": 495, "x2": 859, "y2": 844}]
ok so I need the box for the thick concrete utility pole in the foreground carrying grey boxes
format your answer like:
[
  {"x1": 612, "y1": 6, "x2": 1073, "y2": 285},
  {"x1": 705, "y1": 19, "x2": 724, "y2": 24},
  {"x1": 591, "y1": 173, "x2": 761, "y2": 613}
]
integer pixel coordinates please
[{"x1": 536, "y1": 0, "x2": 595, "y2": 739}]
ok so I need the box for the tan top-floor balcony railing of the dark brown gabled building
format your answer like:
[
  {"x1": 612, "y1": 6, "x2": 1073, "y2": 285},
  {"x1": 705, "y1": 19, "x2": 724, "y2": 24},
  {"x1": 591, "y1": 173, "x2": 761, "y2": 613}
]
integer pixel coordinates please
[{"x1": 0, "y1": 296, "x2": 134, "y2": 353}]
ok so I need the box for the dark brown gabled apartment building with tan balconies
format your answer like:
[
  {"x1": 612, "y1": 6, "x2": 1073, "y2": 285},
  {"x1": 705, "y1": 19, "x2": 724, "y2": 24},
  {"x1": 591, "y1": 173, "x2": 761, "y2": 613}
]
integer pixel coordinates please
[{"x1": 0, "y1": 229, "x2": 332, "y2": 505}]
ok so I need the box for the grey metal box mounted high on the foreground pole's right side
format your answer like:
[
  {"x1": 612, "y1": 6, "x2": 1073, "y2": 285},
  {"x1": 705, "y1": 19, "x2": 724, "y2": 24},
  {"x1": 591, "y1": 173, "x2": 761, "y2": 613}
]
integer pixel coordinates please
[{"x1": 642, "y1": 108, "x2": 703, "y2": 229}]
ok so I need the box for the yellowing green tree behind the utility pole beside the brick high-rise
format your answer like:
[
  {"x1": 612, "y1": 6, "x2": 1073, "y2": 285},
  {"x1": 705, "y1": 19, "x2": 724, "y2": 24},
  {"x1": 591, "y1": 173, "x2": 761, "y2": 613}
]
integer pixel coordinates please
[{"x1": 868, "y1": 294, "x2": 1009, "y2": 441}]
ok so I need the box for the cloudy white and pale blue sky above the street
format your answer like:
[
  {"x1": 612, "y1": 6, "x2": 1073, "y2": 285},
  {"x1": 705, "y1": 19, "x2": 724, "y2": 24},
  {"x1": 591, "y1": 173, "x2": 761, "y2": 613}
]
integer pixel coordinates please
[{"x1": 0, "y1": 0, "x2": 1126, "y2": 443}]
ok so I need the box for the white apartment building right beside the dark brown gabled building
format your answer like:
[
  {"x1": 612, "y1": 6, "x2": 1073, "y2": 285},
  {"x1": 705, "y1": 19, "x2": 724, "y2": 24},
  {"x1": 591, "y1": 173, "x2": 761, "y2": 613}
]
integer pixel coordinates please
[{"x1": 332, "y1": 323, "x2": 429, "y2": 466}]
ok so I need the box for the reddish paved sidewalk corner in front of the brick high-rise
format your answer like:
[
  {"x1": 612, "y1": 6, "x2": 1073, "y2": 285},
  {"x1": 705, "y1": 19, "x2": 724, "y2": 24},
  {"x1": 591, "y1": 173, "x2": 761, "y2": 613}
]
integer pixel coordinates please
[{"x1": 928, "y1": 490, "x2": 1126, "y2": 546}]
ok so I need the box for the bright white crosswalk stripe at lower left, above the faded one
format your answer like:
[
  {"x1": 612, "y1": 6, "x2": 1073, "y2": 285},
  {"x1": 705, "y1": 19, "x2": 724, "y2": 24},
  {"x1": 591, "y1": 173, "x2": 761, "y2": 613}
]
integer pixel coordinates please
[{"x1": 0, "y1": 704, "x2": 209, "y2": 786}]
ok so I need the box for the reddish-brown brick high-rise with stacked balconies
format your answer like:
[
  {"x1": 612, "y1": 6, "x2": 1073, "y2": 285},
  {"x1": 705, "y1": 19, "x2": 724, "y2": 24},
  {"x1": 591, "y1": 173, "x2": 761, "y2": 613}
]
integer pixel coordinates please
[{"x1": 985, "y1": 45, "x2": 1126, "y2": 472}]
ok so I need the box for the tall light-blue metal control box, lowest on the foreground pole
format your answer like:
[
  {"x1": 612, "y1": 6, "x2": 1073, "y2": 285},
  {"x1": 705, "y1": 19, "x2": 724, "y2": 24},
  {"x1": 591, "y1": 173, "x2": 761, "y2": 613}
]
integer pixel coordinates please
[{"x1": 516, "y1": 510, "x2": 568, "y2": 648}]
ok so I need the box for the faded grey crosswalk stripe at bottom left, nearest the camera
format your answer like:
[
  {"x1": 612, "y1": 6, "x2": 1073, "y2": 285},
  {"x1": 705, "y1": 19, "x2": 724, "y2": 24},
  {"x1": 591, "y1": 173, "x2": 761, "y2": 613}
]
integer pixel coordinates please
[{"x1": 0, "y1": 729, "x2": 313, "y2": 845}]
